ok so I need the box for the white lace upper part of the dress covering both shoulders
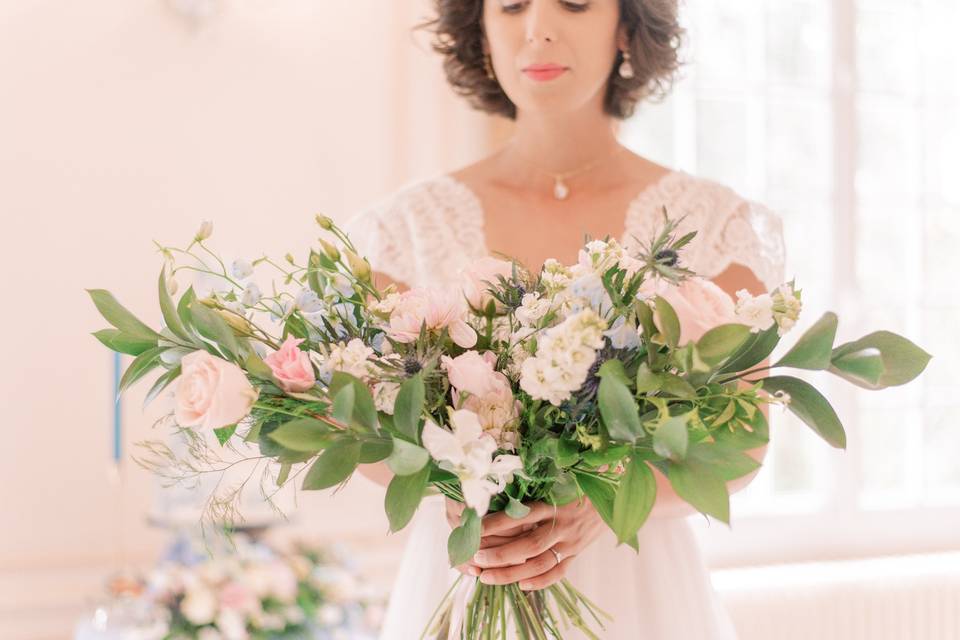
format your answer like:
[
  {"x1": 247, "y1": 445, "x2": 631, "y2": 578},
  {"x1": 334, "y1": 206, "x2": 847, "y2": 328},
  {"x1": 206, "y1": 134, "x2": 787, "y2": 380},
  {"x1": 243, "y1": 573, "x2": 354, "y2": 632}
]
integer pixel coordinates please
[{"x1": 344, "y1": 170, "x2": 786, "y2": 290}]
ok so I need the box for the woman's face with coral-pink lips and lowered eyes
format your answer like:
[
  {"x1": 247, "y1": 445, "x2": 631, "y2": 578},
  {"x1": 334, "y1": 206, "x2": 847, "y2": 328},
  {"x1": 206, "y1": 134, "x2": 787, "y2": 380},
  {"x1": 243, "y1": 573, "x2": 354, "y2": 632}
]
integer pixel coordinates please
[{"x1": 483, "y1": 0, "x2": 626, "y2": 113}]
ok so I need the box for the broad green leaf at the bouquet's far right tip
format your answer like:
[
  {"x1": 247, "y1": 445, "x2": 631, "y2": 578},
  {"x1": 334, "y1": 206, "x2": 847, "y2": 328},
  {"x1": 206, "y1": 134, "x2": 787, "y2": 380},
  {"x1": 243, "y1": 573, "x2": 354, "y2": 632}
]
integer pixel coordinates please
[{"x1": 829, "y1": 331, "x2": 933, "y2": 390}]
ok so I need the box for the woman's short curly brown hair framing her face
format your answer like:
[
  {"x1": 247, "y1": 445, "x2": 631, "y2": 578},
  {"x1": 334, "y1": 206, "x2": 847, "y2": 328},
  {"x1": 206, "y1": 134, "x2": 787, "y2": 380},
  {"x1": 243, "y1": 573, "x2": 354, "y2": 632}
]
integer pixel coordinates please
[{"x1": 416, "y1": 0, "x2": 686, "y2": 120}]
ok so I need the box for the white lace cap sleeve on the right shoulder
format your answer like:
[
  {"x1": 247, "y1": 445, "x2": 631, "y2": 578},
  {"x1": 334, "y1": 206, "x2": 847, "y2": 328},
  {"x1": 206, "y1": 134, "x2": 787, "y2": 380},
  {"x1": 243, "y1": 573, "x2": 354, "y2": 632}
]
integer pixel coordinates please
[{"x1": 700, "y1": 198, "x2": 786, "y2": 291}]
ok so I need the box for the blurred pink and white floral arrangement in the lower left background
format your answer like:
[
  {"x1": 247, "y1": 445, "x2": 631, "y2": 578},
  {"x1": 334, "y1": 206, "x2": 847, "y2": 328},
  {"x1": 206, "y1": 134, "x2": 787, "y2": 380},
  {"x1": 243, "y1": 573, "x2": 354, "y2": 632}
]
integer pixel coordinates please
[{"x1": 90, "y1": 534, "x2": 383, "y2": 640}]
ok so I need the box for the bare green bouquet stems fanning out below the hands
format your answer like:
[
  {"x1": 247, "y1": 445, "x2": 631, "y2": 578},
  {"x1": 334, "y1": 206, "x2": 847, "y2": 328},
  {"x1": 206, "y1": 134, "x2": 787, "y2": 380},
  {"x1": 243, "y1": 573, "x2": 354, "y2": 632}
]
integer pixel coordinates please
[{"x1": 420, "y1": 575, "x2": 612, "y2": 640}]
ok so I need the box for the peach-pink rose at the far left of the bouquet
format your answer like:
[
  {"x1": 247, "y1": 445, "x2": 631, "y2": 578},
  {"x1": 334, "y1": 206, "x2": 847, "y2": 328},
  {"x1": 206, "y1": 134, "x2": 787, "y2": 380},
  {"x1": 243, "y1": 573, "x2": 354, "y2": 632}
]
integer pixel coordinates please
[{"x1": 174, "y1": 351, "x2": 257, "y2": 429}]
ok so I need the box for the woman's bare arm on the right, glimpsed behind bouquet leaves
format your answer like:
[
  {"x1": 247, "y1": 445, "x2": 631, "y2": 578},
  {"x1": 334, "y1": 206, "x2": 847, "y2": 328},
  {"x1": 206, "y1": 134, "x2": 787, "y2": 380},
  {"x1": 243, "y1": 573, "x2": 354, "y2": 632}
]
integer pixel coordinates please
[{"x1": 650, "y1": 263, "x2": 770, "y2": 518}]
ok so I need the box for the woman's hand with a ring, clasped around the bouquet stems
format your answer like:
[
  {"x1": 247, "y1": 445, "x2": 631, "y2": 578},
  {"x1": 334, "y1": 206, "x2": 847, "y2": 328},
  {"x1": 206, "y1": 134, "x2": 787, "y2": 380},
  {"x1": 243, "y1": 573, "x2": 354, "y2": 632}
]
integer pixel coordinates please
[{"x1": 465, "y1": 498, "x2": 605, "y2": 591}]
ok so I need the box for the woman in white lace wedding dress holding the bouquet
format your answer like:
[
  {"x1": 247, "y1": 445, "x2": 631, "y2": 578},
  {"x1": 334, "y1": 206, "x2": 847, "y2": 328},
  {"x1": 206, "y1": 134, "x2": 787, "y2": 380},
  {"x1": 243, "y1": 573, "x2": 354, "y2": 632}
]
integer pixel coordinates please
[{"x1": 346, "y1": 0, "x2": 784, "y2": 640}]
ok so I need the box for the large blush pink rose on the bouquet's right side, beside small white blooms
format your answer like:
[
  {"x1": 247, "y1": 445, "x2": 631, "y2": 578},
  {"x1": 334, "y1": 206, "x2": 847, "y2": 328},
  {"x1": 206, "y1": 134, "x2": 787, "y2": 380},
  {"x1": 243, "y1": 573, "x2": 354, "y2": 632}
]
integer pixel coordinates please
[{"x1": 640, "y1": 277, "x2": 739, "y2": 344}]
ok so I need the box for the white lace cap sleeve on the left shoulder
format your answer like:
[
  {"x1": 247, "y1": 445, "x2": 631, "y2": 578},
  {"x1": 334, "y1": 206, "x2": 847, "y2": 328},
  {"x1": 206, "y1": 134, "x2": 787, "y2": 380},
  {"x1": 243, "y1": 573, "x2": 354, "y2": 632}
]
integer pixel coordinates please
[{"x1": 342, "y1": 196, "x2": 417, "y2": 287}]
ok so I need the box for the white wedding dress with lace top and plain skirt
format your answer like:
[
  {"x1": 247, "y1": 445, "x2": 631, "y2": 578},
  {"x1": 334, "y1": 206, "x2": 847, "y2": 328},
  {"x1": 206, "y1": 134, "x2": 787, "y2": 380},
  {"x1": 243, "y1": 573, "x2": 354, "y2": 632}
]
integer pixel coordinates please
[{"x1": 345, "y1": 171, "x2": 785, "y2": 640}]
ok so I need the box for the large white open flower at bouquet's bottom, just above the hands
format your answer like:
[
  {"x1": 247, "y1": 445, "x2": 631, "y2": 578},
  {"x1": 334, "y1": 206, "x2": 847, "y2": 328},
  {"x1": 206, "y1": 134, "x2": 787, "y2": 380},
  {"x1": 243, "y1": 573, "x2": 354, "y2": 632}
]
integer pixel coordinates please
[{"x1": 423, "y1": 409, "x2": 523, "y2": 516}]
